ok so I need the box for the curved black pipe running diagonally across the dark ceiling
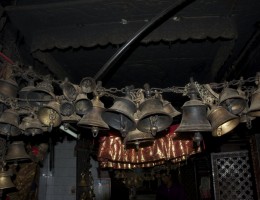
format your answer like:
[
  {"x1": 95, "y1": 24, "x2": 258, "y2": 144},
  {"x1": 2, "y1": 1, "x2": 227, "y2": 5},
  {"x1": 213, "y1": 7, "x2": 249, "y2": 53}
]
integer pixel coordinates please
[{"x1": 94, "y1": 0, "x2": 192, "y2": 80}]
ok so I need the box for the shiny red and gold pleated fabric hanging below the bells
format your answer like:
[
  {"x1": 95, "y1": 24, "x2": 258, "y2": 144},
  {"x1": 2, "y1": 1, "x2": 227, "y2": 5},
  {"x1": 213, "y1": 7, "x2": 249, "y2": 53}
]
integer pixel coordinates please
[{"x1": 98, "y1": 125, "x2": 198, "y2": 169}]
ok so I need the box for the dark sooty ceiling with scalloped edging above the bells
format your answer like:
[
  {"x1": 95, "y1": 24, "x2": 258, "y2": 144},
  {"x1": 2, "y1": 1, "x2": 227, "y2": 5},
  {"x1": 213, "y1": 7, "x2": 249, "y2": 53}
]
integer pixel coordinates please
[{"x1": 2, "y1": 0, "x2": 260, "y2": 106}]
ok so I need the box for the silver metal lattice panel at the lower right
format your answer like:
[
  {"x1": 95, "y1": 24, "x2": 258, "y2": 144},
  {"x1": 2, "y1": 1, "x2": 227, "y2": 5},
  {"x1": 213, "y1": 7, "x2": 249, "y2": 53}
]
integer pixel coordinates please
[{"x1": 211, "y1": 151, "x2": 254, "y2": 200}]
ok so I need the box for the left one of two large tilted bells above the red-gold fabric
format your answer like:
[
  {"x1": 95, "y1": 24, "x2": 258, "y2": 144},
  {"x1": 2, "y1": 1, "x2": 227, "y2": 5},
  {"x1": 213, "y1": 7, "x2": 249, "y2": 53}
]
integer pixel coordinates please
[{"x1": 101, "y1": 97, "x2": 137, "y2": 133}]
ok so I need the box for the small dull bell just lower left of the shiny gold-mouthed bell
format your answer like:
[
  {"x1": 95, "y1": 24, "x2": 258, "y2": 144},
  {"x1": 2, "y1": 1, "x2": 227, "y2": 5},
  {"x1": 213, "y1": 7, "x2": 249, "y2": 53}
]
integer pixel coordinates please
[{"x1": 19, "y1": 116, "x2": 47, "y2": 136}]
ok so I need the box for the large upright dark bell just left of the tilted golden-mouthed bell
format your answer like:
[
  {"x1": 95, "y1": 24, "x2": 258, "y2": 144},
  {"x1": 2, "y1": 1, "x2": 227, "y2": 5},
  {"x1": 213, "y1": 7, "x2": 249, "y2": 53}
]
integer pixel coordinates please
[{"x1": 175, "y1": 99, "x2": 211, "y2": 133}]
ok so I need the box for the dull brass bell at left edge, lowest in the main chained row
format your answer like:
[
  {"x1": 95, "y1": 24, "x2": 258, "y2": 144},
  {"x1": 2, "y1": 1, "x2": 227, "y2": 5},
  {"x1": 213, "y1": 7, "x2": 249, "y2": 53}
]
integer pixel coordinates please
[{"x1": 0, "y1": 109, "x2": 21, "y2": 136}]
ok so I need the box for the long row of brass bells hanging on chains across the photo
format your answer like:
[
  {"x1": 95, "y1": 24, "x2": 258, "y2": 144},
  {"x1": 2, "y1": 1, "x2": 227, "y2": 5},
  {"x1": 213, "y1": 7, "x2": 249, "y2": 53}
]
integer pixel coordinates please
[{"x1": 0, "y1": 63, "x2": 260, "y2": 153}]
